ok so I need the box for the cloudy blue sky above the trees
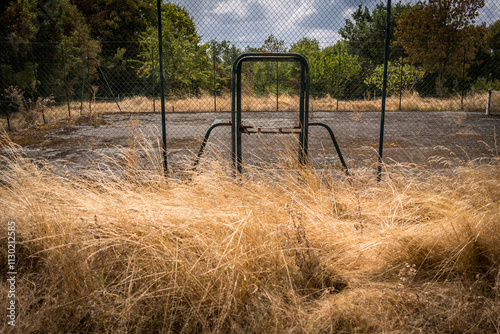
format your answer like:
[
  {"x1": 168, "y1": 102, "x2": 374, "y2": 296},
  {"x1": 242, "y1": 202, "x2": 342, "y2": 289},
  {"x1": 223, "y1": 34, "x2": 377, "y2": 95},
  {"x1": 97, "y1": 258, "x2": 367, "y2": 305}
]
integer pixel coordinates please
[{"x1": 172, "y1": 0, "x2": 500, "y2": 48}]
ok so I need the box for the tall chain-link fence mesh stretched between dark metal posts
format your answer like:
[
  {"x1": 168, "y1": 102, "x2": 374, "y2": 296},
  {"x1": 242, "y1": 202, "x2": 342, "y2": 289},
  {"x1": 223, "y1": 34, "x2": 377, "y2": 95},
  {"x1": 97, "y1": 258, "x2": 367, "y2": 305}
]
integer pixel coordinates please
[{"x1": 0, "y1": 0, "x2": 500, "y2": 172}]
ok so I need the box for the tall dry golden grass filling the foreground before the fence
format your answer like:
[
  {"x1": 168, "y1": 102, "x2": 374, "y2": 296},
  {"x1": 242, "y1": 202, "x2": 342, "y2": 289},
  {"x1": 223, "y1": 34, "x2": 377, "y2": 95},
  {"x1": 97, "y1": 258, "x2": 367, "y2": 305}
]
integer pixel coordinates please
[{"x1": 0, "y1": 137, "x2": 500, "y2": 333}]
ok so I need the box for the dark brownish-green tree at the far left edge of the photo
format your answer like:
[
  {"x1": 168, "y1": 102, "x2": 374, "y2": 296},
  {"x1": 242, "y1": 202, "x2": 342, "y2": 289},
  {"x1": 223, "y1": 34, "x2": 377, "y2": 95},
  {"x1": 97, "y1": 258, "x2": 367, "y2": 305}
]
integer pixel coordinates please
[{"x1": 0, "y1": 0, "x2": 99, "y2": 100}]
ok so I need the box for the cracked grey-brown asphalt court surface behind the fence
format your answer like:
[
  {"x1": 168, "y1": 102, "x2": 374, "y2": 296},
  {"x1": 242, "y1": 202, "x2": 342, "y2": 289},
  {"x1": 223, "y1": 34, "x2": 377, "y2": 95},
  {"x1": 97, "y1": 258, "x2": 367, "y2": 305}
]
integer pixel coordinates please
[{"x1": 3, "y1": 111, "x2": 500, "y2": 174}]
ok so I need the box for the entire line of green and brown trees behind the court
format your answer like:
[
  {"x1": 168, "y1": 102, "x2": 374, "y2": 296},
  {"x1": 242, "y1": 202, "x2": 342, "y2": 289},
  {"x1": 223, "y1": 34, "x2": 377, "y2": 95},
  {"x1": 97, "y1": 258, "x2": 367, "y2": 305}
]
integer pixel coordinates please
[{"x1": 0, "y1": 0, "x2": 500, "y2": 115}]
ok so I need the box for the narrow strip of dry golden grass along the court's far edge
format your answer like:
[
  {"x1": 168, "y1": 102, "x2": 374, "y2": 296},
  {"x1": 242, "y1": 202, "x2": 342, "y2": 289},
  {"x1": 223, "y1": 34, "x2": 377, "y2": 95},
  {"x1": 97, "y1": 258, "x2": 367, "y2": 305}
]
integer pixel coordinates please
[{"x1": 0, "y1": 92, "x2": 492, "y2": 133}]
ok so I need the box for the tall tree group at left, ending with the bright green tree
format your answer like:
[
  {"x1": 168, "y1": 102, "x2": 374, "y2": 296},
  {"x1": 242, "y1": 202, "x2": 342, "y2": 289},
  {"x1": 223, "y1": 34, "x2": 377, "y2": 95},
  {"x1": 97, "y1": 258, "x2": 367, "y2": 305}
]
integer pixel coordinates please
[{"x1": 0, "y1": 0, "x2": 210, "y2": 101}]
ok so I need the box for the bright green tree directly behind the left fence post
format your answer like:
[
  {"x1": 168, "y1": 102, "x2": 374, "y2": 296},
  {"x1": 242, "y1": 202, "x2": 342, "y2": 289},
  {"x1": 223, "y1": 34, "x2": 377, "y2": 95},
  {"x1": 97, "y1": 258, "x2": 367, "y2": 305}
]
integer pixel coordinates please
[{"x1": 135, "y1": 3, "x2": 212, "y2": 95}]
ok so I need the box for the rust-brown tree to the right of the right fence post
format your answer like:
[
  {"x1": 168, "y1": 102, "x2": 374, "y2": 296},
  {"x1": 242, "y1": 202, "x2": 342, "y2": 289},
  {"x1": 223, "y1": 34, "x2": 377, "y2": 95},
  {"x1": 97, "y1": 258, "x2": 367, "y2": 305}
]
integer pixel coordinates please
[{"x1": 396, "y1": 0, "x2": 484, "y2": 97}]
